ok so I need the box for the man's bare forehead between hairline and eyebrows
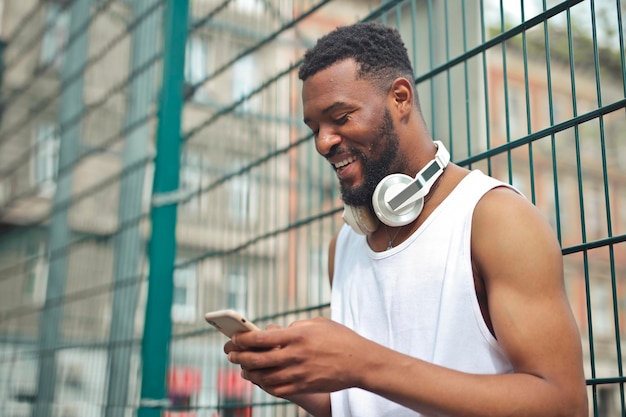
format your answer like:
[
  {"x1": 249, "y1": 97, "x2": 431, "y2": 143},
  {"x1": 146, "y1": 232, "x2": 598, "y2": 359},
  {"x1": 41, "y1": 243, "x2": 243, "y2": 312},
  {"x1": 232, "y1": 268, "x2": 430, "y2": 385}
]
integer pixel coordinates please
[{"x1": 302, "y1": 59, "x2": 375, "y2": 119}]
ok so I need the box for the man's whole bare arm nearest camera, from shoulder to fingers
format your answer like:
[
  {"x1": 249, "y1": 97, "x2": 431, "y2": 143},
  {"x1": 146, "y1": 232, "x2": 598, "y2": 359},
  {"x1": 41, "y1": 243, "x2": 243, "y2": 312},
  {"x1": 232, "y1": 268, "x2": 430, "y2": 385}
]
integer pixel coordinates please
[{"x1": 229, "y1": 189, "x2": 587, "y2": 417}]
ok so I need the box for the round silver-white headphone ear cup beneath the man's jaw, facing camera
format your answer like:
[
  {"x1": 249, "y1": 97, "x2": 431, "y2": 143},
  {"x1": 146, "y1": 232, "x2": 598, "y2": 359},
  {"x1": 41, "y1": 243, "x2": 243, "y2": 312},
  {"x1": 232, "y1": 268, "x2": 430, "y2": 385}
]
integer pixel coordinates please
[{"x1": 372, "y1": 174, "x2": 424, "y2": 227}]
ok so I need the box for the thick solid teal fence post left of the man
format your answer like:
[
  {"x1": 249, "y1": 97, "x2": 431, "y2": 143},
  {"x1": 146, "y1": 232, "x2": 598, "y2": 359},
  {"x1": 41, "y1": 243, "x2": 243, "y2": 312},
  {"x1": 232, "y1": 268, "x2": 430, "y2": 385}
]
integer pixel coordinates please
[{"x1": 138, "y1": 0, "x2": 189, "y2": 417}]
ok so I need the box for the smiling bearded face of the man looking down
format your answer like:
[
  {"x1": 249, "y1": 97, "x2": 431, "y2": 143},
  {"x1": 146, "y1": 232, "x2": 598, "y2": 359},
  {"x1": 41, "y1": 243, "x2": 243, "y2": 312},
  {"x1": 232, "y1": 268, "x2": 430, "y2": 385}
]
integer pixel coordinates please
[{"x1": 302, "y1": 59, "x2": 406, "y2": 206}]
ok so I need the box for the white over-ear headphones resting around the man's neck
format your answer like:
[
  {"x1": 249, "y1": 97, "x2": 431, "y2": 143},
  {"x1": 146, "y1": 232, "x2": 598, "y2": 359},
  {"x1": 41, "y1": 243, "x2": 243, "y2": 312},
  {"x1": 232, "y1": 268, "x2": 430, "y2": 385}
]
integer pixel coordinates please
[{"x1": 343, "y1": 140, "x2": 450, "y2": 235}]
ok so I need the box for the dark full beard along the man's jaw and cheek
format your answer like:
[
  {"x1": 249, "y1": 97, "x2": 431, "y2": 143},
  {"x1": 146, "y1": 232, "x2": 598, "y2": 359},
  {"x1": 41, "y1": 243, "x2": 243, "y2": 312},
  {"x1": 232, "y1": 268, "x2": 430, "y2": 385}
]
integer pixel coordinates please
[{"x1": 339, "y1": 109, "x2": 406, "y2": 209}]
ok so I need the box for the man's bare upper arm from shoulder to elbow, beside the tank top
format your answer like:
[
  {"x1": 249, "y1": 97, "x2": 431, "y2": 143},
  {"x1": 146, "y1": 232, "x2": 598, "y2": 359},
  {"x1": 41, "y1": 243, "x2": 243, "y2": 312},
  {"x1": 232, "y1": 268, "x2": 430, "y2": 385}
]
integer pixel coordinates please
[{"x1": 472, "y1": 190, "x2": 582, "y2": 383}]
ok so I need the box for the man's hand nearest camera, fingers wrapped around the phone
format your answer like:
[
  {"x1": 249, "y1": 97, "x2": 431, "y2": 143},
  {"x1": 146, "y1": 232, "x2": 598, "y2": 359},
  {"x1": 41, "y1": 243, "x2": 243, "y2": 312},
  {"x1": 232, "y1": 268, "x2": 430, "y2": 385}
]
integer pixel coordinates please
[{"x1": 224, "y1": 318, "x2": 364, "y2": 398}]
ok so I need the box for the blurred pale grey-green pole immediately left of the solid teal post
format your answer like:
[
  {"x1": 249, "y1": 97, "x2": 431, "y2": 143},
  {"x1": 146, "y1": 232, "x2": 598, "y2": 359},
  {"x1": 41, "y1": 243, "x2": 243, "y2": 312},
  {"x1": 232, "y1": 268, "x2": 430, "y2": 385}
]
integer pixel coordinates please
[{"x1": 105, "y1": 0, "x2": 162, "y2": 417}]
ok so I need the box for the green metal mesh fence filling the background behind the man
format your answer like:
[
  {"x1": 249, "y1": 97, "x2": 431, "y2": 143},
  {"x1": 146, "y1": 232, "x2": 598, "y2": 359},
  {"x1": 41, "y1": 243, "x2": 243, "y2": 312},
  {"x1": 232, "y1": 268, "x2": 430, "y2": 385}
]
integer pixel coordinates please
[{"x1": 0, "y1": 0, "x2": 626, "y2": 417}]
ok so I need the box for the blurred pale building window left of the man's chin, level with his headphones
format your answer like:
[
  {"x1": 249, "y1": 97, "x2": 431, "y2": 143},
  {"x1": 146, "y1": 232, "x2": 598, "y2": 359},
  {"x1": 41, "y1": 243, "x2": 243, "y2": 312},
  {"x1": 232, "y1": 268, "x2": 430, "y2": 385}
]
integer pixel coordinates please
[{"x1": 230, "y1": 175, "x2": 259, "y2": 226}]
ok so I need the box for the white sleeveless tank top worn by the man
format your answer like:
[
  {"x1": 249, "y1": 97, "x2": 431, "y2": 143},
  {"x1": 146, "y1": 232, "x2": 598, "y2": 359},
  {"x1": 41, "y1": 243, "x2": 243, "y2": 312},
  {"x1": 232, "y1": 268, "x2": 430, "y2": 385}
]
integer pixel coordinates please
[{"x1": 331, "y1": 171, "x2": 512, "y2": 417}]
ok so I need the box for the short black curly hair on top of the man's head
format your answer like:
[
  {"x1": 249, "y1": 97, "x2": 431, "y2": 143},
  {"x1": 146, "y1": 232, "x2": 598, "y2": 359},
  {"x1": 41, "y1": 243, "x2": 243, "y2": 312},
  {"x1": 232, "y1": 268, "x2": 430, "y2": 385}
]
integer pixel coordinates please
[{"x1": 298, "y1": 22, "x2": 417, "y2": 97}]
